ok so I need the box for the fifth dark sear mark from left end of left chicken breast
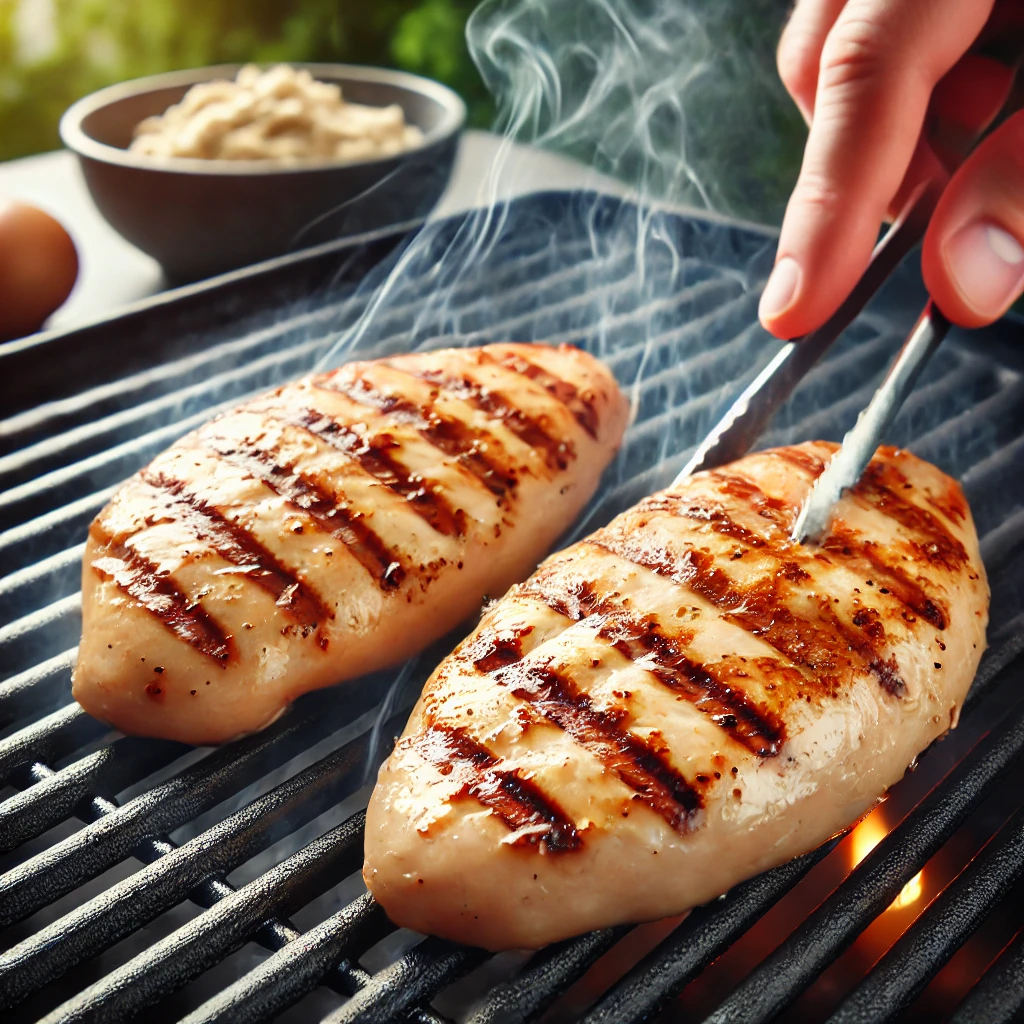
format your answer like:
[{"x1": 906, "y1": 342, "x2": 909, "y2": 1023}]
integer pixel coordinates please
[{"x1": 314, "y1": 376, "x2": 516, "y2": 498}]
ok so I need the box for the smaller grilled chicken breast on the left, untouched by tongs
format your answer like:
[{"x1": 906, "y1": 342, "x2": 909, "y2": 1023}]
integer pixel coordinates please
[{"x1": 74, "y1": 344, "x2": 628, "y2": 743}]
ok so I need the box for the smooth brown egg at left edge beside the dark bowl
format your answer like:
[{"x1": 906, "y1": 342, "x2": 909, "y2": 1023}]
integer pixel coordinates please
[{"x1": 0, "y1": 200, "x2": 78, "y2": 341}]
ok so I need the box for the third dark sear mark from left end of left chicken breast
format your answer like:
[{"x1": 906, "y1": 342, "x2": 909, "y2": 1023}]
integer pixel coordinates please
[{"x1": 199, "y1": 434, "x2": 406, "y2": 590}]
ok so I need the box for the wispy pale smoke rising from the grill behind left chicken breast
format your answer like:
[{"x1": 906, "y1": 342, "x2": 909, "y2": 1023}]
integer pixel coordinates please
[{"x1": 322, "y1": 0, "x2": 803, "y2": 368}]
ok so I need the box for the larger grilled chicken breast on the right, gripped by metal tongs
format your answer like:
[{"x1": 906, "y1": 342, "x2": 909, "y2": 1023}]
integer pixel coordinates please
[{"x1": 364, "y1": 443, "x2": 988, "y2": 949}]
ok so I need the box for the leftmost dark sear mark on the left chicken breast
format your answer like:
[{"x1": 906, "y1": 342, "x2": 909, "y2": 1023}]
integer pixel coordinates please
[{"x1": 91, "y1": 524, "x2": 232, "y2": 668}]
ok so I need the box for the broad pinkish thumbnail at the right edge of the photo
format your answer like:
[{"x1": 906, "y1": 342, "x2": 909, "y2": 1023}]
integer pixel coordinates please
[{"x1": 943, "y1": 220, "x2": 1024, "y2": 317}]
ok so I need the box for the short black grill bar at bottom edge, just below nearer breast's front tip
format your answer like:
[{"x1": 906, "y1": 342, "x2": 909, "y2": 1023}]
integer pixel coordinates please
[{"x1": 324, "y1": 936, "x2": 489, "y2": 1024}]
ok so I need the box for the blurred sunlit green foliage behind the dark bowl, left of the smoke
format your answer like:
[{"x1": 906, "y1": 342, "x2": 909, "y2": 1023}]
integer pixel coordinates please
[{"x1": 0, "y1": 0, "x2": 492, "y2": 160}]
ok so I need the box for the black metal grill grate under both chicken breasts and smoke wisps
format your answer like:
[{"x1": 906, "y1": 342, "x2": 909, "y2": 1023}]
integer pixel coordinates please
[{"x1": 0, "y1": 194, "x2": 1024, "y2": 1024}]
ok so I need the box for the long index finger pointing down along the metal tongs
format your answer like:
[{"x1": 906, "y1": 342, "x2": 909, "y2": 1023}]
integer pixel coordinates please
[{"x1": 760, "y1": 0, "x2": 991, "y2": 338}]
